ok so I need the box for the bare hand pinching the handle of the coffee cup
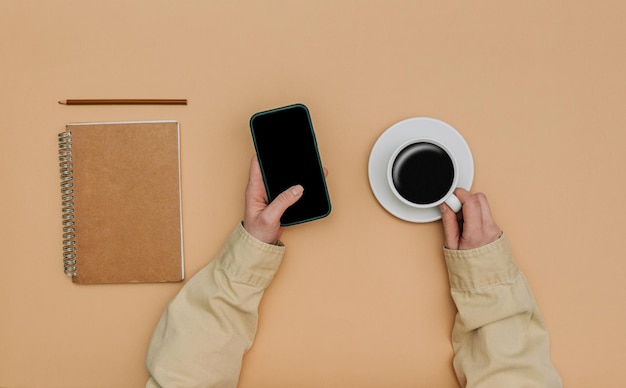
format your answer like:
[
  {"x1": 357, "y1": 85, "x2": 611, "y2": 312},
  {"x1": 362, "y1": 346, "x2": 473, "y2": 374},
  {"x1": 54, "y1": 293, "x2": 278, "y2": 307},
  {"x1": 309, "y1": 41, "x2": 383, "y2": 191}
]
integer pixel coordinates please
[{"x1": 440, "y1": 188, "x2": 502, "y2": 249}]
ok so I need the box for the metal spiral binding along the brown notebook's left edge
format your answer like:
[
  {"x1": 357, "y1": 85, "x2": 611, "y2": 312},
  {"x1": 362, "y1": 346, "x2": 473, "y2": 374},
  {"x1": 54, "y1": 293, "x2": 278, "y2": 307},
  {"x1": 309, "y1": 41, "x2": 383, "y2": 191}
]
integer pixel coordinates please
[{"x1": 59, "y1": 131, "x2": 76, "y2": 277}]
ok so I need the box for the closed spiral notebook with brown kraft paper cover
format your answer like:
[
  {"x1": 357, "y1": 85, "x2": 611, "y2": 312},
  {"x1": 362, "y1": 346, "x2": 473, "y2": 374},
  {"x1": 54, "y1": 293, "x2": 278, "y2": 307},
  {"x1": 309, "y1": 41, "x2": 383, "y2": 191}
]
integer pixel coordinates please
[{"x1": 59, "y1": 121, "x2": 184, "y2": 284}]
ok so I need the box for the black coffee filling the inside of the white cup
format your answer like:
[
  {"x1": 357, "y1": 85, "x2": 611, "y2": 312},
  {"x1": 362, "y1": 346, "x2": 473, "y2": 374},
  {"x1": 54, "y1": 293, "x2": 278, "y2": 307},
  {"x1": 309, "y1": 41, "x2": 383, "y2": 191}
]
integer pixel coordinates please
[{"x1": 392, "y1": 143, "x2": 454, "y2": 205}]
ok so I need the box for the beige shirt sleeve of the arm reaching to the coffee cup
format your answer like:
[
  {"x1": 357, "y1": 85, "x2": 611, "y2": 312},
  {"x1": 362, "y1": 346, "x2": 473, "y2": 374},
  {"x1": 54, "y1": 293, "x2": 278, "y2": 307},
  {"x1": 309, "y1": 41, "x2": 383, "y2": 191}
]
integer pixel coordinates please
[{"x1": 444, "y1": 236, "x2": 562, "y2": 388}]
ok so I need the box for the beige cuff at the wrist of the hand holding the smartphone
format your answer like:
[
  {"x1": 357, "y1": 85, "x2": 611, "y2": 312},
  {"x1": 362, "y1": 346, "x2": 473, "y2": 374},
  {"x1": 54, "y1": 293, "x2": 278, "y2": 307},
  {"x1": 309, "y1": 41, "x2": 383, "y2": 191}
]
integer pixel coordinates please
[{"x1": 217, "y1": 224, "x2": 285, "y2": 288}]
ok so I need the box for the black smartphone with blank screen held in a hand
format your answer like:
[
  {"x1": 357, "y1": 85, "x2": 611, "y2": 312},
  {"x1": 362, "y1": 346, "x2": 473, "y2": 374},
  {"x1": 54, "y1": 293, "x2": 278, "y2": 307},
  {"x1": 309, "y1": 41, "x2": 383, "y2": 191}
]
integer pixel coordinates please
[{"x1": 250, "y1": 104, "x2": 331, "y2": 226}]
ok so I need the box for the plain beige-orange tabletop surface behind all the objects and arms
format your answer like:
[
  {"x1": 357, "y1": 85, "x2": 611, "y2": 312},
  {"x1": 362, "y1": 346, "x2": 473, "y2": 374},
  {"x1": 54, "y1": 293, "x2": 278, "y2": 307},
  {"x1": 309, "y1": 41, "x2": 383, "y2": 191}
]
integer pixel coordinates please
[{"x1": 0, "y1": 0, "x2": 626, "y2": 387}]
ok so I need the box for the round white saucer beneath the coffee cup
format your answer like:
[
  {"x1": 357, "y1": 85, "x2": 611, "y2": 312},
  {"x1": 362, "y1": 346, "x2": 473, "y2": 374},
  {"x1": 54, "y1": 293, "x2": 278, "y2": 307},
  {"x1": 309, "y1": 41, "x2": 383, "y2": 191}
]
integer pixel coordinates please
[{"x1": 368, "y1": 117, "x2": 474, "y2": 222}]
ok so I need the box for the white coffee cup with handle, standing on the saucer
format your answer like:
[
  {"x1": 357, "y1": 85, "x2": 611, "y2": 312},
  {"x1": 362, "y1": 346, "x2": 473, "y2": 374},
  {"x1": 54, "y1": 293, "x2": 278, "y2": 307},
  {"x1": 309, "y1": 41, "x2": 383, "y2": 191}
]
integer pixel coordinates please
[{"x1": 387, "y1": 138, "x2": 462, "y2": 212}]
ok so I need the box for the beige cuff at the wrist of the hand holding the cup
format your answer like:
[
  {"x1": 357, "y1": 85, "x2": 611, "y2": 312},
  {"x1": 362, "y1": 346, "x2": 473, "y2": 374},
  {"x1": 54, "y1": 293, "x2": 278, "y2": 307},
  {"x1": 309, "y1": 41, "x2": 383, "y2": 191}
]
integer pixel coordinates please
[{"x1": 444, "y1": 234, "x2": 520, "y2": 292}]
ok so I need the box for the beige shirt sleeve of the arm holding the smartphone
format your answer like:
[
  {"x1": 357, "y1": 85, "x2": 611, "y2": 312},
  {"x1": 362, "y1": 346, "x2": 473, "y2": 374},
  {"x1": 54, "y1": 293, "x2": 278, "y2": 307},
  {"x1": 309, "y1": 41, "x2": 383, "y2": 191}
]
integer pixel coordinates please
[{"x1": 146, "y1": 224, "x2": 284, "y2": 387}]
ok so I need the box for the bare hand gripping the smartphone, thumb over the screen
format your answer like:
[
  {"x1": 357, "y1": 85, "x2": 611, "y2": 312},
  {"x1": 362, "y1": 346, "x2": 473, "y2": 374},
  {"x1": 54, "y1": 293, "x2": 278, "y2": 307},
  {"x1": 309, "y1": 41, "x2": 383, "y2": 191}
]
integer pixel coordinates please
[{"x1": 243, "y1": 155, "x2": 304, "y2": 244}]
